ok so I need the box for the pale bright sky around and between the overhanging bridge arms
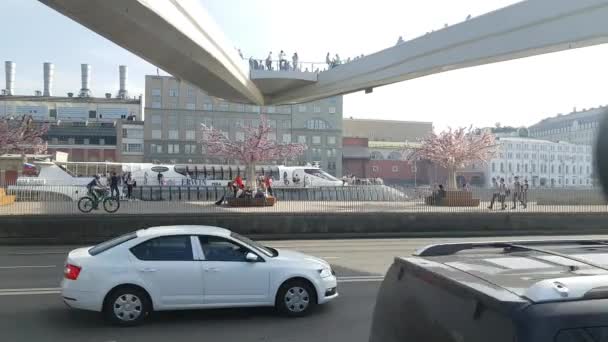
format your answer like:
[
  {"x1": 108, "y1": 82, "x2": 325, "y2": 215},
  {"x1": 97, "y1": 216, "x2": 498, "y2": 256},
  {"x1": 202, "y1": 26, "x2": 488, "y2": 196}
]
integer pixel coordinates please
[{"x1": 0, "y1": 0, "x2": 608, "y2": 129}]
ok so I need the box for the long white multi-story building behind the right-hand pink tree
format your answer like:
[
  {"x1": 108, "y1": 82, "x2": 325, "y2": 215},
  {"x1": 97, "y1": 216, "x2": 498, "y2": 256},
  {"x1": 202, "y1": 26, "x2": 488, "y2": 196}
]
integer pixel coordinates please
[{"x1": 485, "y1": 136, "x2": 594, "y2": 187}]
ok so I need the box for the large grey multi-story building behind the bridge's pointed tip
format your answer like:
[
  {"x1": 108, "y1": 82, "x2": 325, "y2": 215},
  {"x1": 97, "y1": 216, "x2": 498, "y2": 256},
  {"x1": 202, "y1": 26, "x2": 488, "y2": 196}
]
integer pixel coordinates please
[{"x1": 144, "y1": 75, "x2": 342, "y2": 176}]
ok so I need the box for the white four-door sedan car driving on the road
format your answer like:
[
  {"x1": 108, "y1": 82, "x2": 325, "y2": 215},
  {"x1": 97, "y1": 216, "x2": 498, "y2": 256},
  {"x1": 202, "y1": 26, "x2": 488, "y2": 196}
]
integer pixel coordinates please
[{"x1": 61, "y1": 226, "x2": 338, "y2": 325}]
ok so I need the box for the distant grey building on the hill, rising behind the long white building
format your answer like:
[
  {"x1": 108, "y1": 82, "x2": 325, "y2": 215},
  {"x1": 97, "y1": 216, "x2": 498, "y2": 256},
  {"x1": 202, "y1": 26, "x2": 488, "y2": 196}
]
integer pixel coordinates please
[{"x1": 529, "y1": 106, "x2": 608, "y2": 146}]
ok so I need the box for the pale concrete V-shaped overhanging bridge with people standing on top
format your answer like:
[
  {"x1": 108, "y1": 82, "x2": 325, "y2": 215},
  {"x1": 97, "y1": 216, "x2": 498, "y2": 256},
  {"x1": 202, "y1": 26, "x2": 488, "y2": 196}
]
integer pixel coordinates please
[{"x1": 40, "y1": 0, "x2": 608, "y2": 104}]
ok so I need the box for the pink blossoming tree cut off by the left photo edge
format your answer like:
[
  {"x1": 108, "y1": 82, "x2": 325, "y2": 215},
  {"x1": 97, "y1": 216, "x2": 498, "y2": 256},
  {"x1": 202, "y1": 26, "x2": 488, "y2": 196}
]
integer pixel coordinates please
[{"x1": 0, "y1": 116, "x2": 48, "y2": 155}]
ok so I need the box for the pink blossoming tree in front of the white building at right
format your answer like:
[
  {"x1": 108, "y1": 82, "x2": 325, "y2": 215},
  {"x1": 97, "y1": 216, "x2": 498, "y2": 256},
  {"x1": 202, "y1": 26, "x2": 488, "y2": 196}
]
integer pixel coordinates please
[{"x1": 407, "y1": 127, "x2": 496, "y2": 190}]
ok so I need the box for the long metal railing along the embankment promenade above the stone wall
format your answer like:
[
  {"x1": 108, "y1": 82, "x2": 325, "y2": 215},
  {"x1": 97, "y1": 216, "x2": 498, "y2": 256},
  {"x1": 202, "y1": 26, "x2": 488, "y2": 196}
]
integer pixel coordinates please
[{"x1": 0, "y1": 180, "x2": 608, "y2": 215}]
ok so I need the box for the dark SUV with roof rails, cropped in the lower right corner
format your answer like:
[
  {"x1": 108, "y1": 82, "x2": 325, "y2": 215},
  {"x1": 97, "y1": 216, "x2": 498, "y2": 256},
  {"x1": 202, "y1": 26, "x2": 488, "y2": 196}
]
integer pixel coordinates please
[{"x1": 370, "y1": 240, "x2": 608, "y2": 342}]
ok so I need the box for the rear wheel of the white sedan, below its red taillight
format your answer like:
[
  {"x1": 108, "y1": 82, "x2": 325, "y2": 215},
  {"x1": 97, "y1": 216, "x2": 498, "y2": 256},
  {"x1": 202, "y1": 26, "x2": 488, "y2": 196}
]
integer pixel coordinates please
[{"x1": 104, "y1": 287, "x2": 152, "y2": 326}]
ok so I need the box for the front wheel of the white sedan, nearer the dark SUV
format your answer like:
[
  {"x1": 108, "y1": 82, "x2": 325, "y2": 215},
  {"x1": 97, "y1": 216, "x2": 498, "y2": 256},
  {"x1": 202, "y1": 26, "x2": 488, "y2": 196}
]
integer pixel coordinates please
[{"x1": 276, "y1": 280, "x2": 317, "y2": 317}]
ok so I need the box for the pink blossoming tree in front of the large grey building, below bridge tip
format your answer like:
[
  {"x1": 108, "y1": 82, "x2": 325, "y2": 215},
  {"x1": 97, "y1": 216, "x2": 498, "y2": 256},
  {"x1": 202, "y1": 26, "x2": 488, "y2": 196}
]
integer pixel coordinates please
[{"x1": 200, "y1": 116, "x2": 306, "y2": 184}]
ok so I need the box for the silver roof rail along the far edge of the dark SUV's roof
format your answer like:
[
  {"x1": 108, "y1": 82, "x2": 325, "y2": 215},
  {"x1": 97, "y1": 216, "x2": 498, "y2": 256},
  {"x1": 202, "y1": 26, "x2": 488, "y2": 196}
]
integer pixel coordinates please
[{"x1": 414, "y1": 239, "x2": 608, "y2": 256}]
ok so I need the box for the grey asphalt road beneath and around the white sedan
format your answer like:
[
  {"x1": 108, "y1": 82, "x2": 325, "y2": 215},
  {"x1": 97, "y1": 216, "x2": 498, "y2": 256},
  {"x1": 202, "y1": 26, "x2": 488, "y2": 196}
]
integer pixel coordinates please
[{"x1": 0, "y1": 236, "x2": 608, "y2": 342}]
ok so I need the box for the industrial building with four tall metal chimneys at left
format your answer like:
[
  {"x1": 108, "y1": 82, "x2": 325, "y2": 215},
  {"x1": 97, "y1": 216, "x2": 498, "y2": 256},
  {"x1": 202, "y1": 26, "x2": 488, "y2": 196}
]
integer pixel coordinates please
[{"x1": 0, "y1": 61, "x2": 143, "y2": 162}]
